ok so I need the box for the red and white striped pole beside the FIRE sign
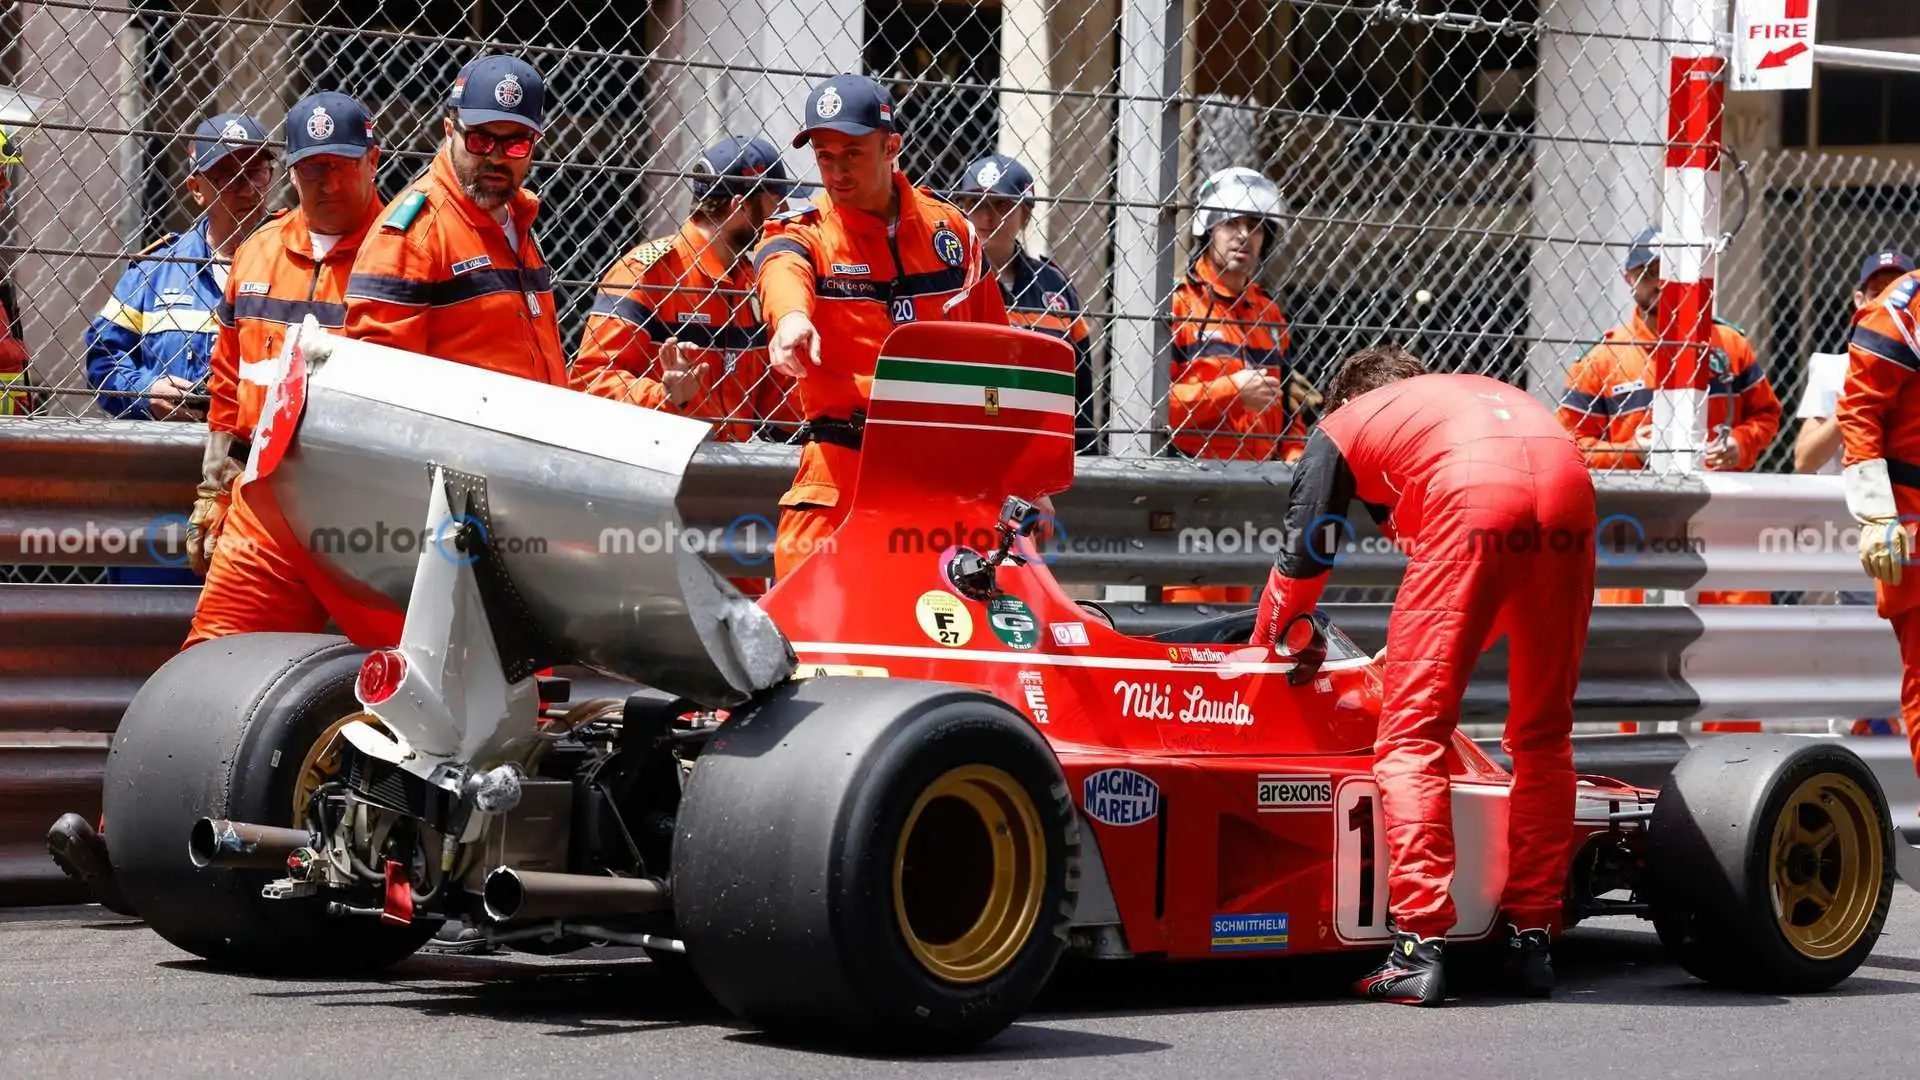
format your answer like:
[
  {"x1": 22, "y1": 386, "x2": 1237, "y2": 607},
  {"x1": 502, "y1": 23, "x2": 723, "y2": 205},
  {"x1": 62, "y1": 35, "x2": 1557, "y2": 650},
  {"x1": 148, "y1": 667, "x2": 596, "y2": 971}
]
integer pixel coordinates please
[{"x1": 1651, "y1": 0, "x2": 1726, "y2": 473}]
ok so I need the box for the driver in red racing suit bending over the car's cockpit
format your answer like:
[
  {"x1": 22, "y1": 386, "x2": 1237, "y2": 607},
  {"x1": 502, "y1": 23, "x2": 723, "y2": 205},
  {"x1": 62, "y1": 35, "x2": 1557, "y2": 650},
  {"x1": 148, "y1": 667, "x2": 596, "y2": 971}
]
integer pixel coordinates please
[{"x1": 1252, "y1": 346, "x2": 1596, "y2": 1005}]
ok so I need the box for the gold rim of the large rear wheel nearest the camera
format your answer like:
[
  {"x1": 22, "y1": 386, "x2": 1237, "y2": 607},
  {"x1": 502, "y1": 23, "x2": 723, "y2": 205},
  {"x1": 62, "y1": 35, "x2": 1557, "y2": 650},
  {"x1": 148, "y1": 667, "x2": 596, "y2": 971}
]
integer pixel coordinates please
[{"x1": 893, "y1": 765, "x2": 1046, "y2": 984}]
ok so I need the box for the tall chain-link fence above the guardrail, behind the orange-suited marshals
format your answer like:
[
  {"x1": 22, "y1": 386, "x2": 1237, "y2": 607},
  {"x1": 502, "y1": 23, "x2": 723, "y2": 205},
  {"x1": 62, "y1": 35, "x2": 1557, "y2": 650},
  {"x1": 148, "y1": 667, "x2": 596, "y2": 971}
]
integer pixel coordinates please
[{"x1": 0, "y1": 0, "x2": 1920, "y2": 469}]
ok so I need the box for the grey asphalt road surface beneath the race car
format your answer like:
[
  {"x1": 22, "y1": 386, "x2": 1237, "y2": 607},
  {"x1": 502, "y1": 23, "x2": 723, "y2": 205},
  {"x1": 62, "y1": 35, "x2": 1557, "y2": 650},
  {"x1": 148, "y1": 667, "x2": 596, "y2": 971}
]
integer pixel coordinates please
[{"x1": 0, "y1": 884, "x2": 1920, "y2": 1080}]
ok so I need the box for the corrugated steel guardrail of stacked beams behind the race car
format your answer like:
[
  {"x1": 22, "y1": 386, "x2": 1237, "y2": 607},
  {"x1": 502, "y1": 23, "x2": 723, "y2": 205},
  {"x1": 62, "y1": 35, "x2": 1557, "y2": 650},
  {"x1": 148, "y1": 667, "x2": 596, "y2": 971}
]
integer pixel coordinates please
[{"x1": 0, "y1": 419, "x2": 1905, "y2": 903}]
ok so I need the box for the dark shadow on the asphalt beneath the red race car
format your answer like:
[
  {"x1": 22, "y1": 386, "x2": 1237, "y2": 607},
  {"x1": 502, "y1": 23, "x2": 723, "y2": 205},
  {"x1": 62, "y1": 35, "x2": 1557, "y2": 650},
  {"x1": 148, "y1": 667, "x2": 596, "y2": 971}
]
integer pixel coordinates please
[{"x1": 135, "y1": 907, "x2": 1920, "y2": 1061}]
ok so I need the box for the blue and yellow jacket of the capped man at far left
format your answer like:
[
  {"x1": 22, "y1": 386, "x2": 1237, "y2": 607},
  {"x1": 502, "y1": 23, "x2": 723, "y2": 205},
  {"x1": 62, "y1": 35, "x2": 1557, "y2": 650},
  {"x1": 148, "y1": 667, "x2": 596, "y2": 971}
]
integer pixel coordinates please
[{"x1": 86, "y1": 217, "x2": 225, "y2": 421}]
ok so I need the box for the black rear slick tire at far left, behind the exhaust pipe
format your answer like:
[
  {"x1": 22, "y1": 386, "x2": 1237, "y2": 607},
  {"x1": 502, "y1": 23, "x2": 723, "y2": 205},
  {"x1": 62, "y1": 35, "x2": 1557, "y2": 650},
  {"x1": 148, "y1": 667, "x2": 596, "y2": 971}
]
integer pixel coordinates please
[{"x1": 104, "y1": 634, "x2": 442, "y2": 974}]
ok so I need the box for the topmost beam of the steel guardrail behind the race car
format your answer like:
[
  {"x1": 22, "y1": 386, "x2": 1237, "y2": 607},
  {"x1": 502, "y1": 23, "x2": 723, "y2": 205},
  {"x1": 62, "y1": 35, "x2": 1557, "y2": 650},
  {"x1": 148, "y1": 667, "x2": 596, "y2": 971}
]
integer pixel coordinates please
[{"x1": 0, "y1": 417, "x2": 1870, "y2": 590}]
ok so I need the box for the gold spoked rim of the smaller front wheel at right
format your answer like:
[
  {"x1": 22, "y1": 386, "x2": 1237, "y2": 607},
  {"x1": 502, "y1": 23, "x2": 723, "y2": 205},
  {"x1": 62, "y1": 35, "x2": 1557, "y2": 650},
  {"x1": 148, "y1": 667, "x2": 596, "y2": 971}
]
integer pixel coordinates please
[{"x1": 1768, "y1": 773, "x2": 1884, "y2": 961}]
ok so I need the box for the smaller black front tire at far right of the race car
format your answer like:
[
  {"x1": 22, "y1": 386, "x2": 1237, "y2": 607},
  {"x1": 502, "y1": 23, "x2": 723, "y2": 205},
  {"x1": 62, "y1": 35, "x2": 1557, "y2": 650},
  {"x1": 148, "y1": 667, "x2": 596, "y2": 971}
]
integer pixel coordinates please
[{"x1": 1644, "y1": 734, "x2": 1893, "y2": 994}]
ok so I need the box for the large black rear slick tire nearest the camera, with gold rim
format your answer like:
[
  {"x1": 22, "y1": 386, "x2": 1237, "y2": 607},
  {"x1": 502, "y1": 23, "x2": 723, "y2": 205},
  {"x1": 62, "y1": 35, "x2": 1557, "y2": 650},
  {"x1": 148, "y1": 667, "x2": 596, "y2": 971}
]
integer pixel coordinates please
[{"x1": 672, "y1": 676, "x2": 1081, "y2": 1053}]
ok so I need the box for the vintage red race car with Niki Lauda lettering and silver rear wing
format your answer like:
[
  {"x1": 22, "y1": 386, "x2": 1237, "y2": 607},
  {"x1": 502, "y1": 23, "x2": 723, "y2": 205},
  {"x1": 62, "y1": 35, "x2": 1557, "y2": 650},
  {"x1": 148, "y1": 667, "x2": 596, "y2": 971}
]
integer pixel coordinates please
[{"x1": 106, "y1": 325, "x2": 1895, "y2": 1049}]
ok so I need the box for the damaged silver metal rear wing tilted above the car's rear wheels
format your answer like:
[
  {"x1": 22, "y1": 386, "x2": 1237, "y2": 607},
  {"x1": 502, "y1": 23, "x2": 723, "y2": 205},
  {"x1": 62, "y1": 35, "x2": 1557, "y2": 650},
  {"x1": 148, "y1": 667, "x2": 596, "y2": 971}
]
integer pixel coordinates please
[{"x1": 248, "y1": 325, "x2": 795, "y2": 707}]
